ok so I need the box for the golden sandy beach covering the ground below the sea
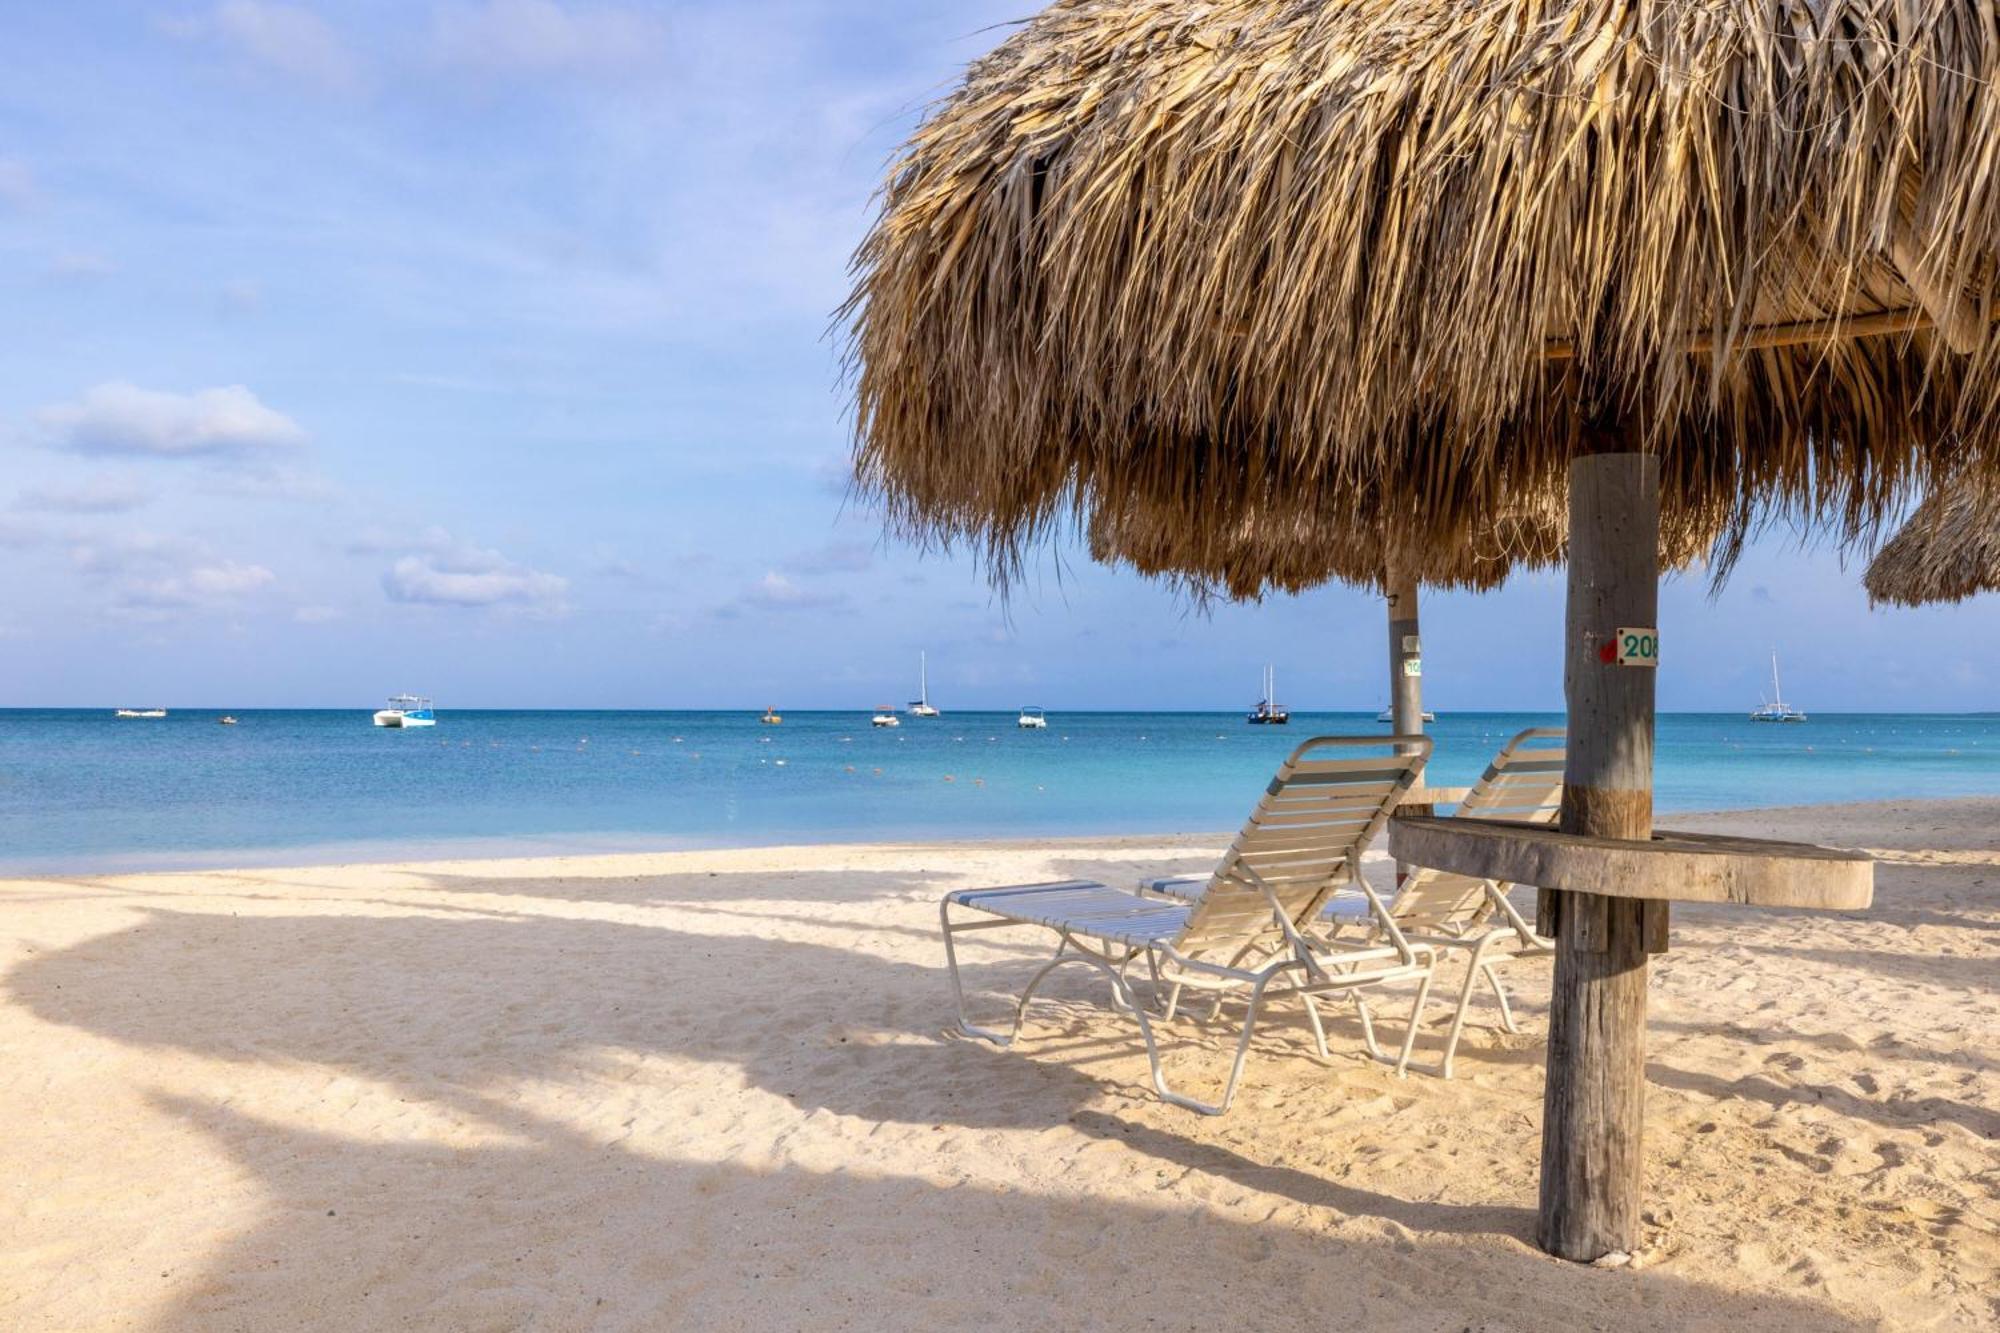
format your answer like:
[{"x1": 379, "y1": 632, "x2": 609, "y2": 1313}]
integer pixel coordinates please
[{"x1": 0, "y1": 801, "x2": 2000, "y2": 1333}]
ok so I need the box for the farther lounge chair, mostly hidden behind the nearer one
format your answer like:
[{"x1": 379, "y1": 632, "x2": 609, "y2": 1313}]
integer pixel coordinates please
[{"x1": 1142, "y1": 727, "x2": 1564, "y2": 1079}]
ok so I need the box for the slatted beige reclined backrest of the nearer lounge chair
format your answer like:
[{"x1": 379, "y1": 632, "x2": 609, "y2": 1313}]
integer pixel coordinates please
[{"x1": 1174, "y1": 737, "x2": 1432, "y2": 957}]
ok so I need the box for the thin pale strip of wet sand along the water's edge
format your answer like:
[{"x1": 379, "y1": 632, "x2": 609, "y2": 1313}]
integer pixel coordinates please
[{"x1": 11, "y1": 793, "x2": 2000, "y2": 885}]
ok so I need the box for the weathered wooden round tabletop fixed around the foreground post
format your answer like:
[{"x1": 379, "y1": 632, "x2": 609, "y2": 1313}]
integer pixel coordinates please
[{"x1": 1388, "y1": 815, "x2": 1874, "y2": 911}]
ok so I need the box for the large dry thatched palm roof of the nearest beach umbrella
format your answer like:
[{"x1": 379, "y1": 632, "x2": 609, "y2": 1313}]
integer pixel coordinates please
[{"x1": 846, "y1": 0, "x2": 2000, "y2": 580}]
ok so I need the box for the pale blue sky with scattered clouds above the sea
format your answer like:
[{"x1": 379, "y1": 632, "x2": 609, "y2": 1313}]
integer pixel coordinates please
[{"x1": 0, "y1": 0, "x2": 2000, "y2": 711}]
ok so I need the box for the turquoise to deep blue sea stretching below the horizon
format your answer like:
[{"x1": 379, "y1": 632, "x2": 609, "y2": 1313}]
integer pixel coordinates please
[{"x1": 0, "y1": 709, "x2": 2000, "y2": 873}]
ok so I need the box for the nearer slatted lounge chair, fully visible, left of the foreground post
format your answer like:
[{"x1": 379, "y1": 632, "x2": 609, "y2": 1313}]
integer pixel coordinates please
[{"x1": 938, "y1": 737, "x2": 1436, "y2": 1115}]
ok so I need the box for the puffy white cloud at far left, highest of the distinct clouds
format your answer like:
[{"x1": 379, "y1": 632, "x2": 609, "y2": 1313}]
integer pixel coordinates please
[{"x1": 38, "y1": 380, "x2": 306, "y2": 458}]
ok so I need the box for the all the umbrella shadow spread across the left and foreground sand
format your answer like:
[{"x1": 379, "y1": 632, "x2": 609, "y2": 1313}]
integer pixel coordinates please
[{"x1": 6, "y1": 860, "x2": 1880, "y2": 1329}]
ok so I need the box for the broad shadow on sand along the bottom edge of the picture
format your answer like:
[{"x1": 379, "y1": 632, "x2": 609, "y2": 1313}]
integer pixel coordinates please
[{"x1": 133, "y1": 1097, "x2": 1864, "y2": 1333}]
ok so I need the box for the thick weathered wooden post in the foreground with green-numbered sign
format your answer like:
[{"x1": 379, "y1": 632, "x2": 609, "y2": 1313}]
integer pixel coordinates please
[{"x1": 1538, "y1": 452, "x2": 1666, "y2": 1263}]
